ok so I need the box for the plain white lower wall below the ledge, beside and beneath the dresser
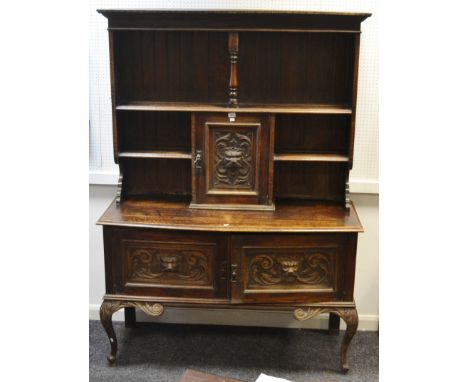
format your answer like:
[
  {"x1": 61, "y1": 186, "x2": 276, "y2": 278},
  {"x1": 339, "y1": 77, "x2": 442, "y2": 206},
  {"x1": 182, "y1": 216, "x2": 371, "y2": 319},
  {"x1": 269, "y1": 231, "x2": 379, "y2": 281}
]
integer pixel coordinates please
[{"x1": 89, "y1": 186, "x2": 379, "y2": 330}]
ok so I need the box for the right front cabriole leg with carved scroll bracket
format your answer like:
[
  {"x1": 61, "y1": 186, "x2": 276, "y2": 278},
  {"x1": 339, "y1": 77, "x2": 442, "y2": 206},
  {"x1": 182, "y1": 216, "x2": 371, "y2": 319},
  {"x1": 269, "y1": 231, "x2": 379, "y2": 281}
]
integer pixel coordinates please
[{"x1": 294, "y1": 307, "x2": 359, "y2": 373}]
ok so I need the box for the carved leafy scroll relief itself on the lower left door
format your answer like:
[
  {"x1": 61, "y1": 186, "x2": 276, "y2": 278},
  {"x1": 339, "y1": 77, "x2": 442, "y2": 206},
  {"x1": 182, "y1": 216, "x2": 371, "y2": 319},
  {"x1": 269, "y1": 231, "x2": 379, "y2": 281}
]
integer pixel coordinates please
[{"x1": 129, "y1": 248, "x2": 209, "y2": 283}]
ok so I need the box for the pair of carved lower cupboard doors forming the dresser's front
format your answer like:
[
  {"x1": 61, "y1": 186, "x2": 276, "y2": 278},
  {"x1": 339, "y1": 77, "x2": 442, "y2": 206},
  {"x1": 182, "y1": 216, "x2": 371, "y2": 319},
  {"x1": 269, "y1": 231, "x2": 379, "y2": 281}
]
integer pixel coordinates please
[{"x1": 104, "y1": 226, "x2": 357, "y2": 304}]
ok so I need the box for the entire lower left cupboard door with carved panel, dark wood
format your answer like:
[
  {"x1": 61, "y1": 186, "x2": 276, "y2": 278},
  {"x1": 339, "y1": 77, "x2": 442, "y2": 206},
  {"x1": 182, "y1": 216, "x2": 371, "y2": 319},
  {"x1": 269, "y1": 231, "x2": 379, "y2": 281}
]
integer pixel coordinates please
[{"x1": 104, "y1": 227, "x2": 228, "y2": 299}]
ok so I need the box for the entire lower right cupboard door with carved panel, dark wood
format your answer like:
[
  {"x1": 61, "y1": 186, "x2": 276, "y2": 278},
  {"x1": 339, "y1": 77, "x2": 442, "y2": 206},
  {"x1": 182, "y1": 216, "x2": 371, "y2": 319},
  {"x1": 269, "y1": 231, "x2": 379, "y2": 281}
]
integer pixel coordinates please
[{"x1": 231, "y1": 234, "x2": 355, "y2": 303}]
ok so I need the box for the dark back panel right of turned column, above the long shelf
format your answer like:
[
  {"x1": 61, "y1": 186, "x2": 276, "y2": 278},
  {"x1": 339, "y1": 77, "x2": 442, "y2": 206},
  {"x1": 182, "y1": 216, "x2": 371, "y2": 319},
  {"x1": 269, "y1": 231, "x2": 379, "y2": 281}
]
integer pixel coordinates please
[{"x1": 238, "y1": 32, "x2": 354, "y2": 105}]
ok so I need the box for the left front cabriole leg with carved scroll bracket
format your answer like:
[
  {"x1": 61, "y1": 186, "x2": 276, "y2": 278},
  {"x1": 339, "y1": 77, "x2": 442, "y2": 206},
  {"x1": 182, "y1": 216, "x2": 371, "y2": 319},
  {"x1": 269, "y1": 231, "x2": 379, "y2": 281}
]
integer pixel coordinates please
[{"x1": 99, "y1": 300, "x2": 164, "y2": 364}]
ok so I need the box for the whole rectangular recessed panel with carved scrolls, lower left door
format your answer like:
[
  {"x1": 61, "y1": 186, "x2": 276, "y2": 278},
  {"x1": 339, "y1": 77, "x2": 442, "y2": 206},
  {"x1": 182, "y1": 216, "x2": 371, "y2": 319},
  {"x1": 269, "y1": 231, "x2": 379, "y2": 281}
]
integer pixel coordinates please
[{"x1": 124, "y1": 241, "x2": 214, "y2": 286}]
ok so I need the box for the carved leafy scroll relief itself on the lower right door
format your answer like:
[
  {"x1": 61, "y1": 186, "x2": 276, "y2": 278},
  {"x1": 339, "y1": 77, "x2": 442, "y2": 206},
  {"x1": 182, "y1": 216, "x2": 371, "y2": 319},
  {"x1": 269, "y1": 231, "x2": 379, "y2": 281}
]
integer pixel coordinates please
[{"x1": 249, "y1": 253, "x2": 333, "y2": 285}]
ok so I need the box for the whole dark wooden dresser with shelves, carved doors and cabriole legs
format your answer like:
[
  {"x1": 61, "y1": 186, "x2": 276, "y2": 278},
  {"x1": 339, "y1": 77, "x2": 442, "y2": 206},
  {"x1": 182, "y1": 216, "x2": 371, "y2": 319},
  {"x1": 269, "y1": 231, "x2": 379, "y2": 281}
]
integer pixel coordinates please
[{"x1": 98, "y1": 10, "x2": 370, "y2": 374}]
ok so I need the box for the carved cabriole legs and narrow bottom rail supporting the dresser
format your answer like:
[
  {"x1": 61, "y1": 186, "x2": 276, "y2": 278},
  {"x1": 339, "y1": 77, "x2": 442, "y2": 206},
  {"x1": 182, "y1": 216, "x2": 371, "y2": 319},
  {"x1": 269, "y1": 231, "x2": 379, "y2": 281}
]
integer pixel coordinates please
[{"x1": 100, "y1": 295, "x2": 358, "y2": 373}]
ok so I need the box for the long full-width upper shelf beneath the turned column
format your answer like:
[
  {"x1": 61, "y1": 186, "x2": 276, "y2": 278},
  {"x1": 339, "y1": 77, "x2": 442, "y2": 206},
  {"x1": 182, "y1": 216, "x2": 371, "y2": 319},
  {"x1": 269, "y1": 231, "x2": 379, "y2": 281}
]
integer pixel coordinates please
[{"x1": 115, "y1": 101, "x2": 352, "y2": 114}]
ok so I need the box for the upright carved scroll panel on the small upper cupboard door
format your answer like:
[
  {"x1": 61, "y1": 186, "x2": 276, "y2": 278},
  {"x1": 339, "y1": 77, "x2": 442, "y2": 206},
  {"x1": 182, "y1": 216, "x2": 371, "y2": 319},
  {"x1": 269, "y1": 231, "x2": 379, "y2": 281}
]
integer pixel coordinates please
[{"x1": 214, "y1": 131, "x2": 252, "y2": 187}]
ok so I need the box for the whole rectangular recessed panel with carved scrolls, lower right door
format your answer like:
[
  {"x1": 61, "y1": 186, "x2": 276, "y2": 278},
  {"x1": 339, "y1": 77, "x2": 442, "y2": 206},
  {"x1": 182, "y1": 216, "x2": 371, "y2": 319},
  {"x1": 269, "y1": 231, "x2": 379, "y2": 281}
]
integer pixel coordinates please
[{"x1": 245, "y1": 248, "x2": 336, "y2": 290}]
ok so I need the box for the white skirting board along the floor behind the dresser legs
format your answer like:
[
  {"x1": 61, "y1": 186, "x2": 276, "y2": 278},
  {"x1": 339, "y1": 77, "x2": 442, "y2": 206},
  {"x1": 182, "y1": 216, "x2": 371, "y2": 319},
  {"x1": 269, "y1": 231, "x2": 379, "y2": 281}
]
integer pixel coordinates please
[{"x1": 89, "y1": 304, "x2": 379, "y2": 331}]
